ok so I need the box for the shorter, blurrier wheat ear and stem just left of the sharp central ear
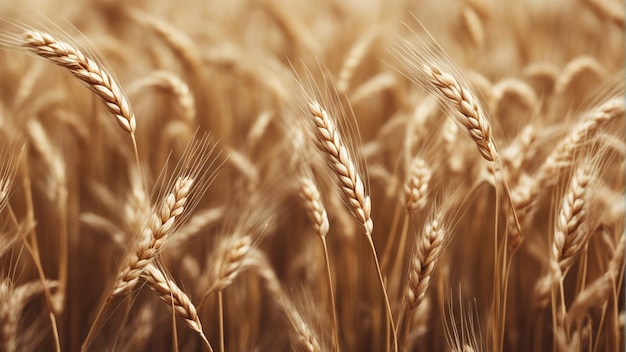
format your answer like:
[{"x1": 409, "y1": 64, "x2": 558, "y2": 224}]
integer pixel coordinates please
[{"x1": 299, "y1": 177, "x2": 339, "y2": 351}]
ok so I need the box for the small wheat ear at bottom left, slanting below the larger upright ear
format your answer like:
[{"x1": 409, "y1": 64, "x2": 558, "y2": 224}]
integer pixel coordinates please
[{"x1": 142, "y1": 263, "x2": 213, "y2": 351}]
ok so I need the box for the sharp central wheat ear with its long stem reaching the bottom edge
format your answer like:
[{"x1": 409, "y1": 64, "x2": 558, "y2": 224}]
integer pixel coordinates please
[{"x1": 308, "y1": 101, "x2": 398, "y2": 351}]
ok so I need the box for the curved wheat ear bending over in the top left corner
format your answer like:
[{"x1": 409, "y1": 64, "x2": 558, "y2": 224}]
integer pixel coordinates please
[{"x1": 21, "y1": 30, "x2": 139, "y2": 164}]
